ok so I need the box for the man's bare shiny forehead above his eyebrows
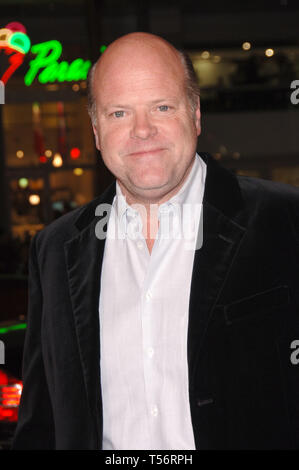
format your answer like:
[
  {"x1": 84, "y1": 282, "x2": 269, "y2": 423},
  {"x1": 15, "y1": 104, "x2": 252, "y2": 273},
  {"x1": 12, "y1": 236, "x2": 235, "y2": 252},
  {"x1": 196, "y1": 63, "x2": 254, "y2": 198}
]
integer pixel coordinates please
[{"x1": 94, "y1": 42, "x2": 184, "y2": 104}]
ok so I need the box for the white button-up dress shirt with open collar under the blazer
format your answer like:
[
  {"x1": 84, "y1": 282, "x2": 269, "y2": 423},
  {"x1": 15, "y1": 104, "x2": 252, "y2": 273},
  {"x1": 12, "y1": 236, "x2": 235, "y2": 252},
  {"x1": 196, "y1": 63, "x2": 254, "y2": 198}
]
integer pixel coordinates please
[{"x1": 99, "y1": 154, "x2": 206, "y2": 450}]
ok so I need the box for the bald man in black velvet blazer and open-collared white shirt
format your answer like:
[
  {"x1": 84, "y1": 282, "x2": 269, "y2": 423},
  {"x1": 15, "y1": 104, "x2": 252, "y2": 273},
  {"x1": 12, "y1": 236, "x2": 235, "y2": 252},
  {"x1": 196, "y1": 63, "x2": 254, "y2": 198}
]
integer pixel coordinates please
[{"x1": 13, "y1": 33, "x2": 299, "y2": 450}]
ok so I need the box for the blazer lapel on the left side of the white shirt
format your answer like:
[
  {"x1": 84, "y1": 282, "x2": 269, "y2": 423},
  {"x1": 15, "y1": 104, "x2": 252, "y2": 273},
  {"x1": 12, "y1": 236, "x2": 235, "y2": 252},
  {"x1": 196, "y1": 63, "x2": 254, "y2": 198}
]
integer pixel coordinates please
[{"x1": 64, "y1": 179, "x2": 115, "y2": 429}]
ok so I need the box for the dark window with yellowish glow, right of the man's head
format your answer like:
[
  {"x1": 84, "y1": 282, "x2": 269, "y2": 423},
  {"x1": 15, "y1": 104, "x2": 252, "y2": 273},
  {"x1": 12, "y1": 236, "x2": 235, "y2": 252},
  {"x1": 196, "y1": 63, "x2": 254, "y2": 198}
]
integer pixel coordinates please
[{"x1": 189, "y1": 42, "x2": 299, "y2": 113}]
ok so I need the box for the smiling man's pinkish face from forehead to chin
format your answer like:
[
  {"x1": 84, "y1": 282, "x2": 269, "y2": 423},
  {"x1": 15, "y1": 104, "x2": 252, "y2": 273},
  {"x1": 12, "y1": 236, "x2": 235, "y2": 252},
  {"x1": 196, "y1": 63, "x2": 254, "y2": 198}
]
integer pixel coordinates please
[{"x1": 94, "y1": 43, "x2": 200, "y2": 203}]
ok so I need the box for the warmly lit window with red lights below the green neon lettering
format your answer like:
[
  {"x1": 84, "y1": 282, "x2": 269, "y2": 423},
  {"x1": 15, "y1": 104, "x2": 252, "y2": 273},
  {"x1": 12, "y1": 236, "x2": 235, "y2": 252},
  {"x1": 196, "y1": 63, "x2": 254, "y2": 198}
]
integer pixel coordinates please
[{"x1": 3, "y1": 92, "x2": 95, "y2": 168}]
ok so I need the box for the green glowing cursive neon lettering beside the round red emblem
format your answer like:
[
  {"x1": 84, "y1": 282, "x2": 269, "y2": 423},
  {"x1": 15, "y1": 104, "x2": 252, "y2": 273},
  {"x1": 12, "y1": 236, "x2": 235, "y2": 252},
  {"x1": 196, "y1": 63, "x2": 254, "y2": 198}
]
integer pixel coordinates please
[{"x1": 24, "y1": 39, "x2": 91, "y2": 86}]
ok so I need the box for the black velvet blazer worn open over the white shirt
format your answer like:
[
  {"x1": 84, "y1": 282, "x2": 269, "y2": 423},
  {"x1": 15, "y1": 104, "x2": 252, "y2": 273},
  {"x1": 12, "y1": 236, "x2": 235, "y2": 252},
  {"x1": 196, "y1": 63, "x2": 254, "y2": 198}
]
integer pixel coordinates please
[{"x1": 13, "y1": 154, "x2": 299, "y2": 449}]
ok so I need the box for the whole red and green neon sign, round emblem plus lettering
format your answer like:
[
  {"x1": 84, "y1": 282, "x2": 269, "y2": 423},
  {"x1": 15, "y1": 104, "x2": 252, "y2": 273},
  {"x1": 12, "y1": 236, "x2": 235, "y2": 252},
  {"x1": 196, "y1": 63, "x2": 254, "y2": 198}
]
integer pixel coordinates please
[{"x1": 0, "y1": 22, "x2": 92, "y2": 86}]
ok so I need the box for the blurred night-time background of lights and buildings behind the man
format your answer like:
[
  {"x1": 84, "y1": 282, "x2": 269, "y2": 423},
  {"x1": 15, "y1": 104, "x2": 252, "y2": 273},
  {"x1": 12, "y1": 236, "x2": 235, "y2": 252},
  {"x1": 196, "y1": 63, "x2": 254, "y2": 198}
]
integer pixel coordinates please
[{"x1": 0, "y1": 0, "x2": 299, "y2": 444}]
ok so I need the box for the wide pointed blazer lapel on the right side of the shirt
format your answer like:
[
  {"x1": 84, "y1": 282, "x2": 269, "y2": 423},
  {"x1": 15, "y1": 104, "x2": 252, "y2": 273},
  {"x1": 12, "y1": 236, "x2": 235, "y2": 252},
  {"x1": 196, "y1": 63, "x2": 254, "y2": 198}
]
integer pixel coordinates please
[{"x1": 188, "y1": 154, "x2": 246, "y2": 383}]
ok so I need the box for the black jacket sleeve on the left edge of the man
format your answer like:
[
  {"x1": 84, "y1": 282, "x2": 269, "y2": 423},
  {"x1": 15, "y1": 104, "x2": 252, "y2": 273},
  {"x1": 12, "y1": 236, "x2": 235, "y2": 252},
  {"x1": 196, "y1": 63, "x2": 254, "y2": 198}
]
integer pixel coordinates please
[{"x1": 12, "y1": 235, "x2": 55, "y2": 450}]
